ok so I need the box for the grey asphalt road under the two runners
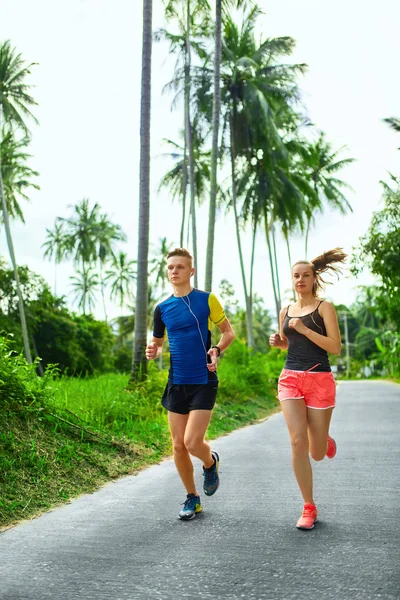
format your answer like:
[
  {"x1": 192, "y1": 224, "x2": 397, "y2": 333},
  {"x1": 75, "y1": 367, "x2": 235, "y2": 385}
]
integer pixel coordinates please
[{"x1": 0, "y1": 382, "x2": 400, "y2": 600}]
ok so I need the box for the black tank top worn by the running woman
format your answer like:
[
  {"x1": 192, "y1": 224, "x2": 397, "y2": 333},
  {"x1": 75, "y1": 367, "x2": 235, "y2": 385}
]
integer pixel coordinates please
[{"x1": 282, "y1": 300, "x2": 331, "y2": 372}]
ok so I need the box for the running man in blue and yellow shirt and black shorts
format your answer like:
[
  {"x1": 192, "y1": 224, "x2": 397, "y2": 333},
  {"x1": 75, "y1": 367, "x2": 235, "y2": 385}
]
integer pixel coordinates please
[{"x1": 146, "y1": 248, "x2": 234, "y2": 520}]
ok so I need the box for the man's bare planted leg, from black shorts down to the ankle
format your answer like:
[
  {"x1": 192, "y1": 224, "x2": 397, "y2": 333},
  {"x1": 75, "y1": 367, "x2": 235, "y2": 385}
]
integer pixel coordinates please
[{"x1": 168, "y1": 411, "x2": 199, "y2": 496}]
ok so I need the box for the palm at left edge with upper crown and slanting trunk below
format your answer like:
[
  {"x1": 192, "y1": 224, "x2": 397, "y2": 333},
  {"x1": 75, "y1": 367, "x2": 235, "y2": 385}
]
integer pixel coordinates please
[{"x1": 0, "y1": 41, "x2": 37, "y2": 363}]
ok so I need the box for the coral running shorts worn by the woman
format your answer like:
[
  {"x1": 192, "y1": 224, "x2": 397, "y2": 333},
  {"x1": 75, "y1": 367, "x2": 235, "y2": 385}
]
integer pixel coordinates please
[{"x1": 277, "y1": 369, "x2": 336, "y2": 409}]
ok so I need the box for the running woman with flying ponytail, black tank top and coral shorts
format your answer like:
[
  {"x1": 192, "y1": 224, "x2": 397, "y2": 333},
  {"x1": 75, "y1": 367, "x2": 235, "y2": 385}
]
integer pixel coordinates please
[{"x1": 269, "y1": 248, "x2": 346, "y2": 529}]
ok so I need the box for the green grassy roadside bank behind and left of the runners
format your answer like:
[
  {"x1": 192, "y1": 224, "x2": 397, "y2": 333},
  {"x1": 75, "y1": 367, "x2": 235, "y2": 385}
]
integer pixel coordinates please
[{"x1": 0, "y1": 349, "x2": 280, "y2": 528}]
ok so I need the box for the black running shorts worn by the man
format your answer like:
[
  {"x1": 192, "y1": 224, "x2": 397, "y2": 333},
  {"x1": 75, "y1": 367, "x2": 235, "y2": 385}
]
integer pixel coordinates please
[{"x1": 161, "y1": 381, "x2": 218, "y2": 415}]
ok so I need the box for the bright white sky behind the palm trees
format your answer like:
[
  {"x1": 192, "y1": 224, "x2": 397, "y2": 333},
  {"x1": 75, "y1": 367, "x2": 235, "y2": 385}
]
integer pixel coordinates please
[{"x1": 0, "y1": 0, "x2": 400, "y2": 318}]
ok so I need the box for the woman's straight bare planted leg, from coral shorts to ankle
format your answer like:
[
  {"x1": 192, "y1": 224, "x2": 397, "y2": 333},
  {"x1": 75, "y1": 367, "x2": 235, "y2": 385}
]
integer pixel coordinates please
[{"x1": 281, "y1": 398, "x2": 315, "y2": 504}]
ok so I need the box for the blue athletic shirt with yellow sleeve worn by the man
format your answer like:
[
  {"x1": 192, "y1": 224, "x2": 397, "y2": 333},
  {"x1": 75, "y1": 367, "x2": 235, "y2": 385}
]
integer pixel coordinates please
[{"x1": 153, "y1": 289, "x2": 226, "y2": 385}]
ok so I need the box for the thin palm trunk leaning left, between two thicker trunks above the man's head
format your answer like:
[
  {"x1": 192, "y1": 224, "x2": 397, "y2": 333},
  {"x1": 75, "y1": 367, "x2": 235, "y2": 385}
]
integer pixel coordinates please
[{"x1": 185, "y1": 0, "x2": 197, "y2": 287}]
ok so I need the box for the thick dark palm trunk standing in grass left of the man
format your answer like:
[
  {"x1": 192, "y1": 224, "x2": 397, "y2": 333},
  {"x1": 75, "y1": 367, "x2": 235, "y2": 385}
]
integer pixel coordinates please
[{"x1": 131, "y1": 0, "x2": 153, "y2": 381}]
